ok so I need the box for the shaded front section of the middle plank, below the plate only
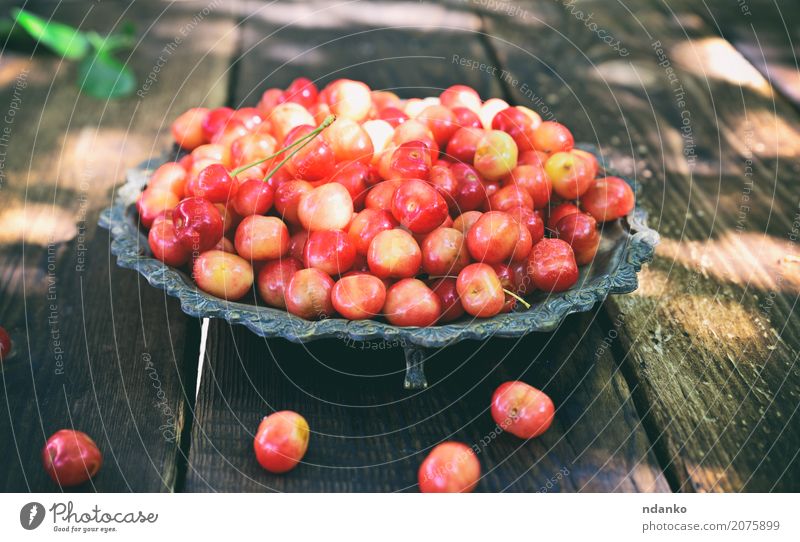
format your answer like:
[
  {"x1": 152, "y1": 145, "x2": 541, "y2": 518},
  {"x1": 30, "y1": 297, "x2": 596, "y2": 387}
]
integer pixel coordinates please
[{"x1": 186, "y1": 315, "x2": 669, "y2": 492}]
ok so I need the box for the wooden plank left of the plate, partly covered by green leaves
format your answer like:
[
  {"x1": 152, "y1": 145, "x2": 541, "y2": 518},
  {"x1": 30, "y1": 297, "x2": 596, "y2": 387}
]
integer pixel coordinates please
[{"x1": 0, "y1": 2, "x2": 233, "y2": 491}]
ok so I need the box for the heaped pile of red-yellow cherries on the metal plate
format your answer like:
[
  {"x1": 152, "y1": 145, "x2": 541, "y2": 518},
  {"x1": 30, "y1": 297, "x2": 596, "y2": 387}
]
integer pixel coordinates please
[{"x1": 137, "y1": 78, "x2": 634, "y2": 326}]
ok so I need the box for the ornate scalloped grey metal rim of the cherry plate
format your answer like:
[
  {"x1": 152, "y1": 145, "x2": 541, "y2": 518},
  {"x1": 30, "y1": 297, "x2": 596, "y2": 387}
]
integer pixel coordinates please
[{"x1": 100, "y1": 145, "x2": 658, "y2": 348}]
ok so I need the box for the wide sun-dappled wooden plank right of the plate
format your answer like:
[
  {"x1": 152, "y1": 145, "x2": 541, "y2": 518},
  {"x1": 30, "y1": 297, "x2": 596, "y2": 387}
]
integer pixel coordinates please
[{"x1": 484, "y1": 1, "x2": 800, "y2": 491}]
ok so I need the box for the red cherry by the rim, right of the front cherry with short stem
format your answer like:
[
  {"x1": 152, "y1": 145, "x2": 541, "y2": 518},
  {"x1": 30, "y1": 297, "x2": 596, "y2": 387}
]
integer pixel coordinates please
[{"x1": 528, "y1": 239, "x2": 578, "y2": 292}]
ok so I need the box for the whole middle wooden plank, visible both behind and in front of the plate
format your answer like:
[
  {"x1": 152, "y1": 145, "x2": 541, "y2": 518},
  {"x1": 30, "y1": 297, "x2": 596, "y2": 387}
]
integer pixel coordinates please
[{"x1": 185, "y1": 3, "x2": 669, "y2": 491}]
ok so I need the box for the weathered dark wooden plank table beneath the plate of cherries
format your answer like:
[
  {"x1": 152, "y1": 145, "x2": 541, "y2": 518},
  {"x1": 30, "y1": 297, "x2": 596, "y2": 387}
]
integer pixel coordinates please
[{"x1": 0, "y1": 0, "x2": 800, "y2": 492}]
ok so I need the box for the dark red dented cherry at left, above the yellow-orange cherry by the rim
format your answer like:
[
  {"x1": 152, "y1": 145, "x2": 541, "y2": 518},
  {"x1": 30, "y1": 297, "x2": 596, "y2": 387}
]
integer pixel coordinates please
[{"x1": 172, "y1": 198, "x2": 224, "y2": 254}]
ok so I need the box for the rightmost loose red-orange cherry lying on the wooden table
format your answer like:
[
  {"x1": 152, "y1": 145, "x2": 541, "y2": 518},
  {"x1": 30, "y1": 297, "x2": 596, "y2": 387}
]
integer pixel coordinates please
[{"x1": 492, "y1": 381, "x2": 555, "y2": 439}]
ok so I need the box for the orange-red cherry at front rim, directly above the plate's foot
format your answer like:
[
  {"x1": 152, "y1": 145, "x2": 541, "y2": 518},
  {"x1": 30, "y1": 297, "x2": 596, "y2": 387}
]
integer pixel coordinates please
[{"x1": 383, "y1": 278, "x2": 442, "y2": 327}]
